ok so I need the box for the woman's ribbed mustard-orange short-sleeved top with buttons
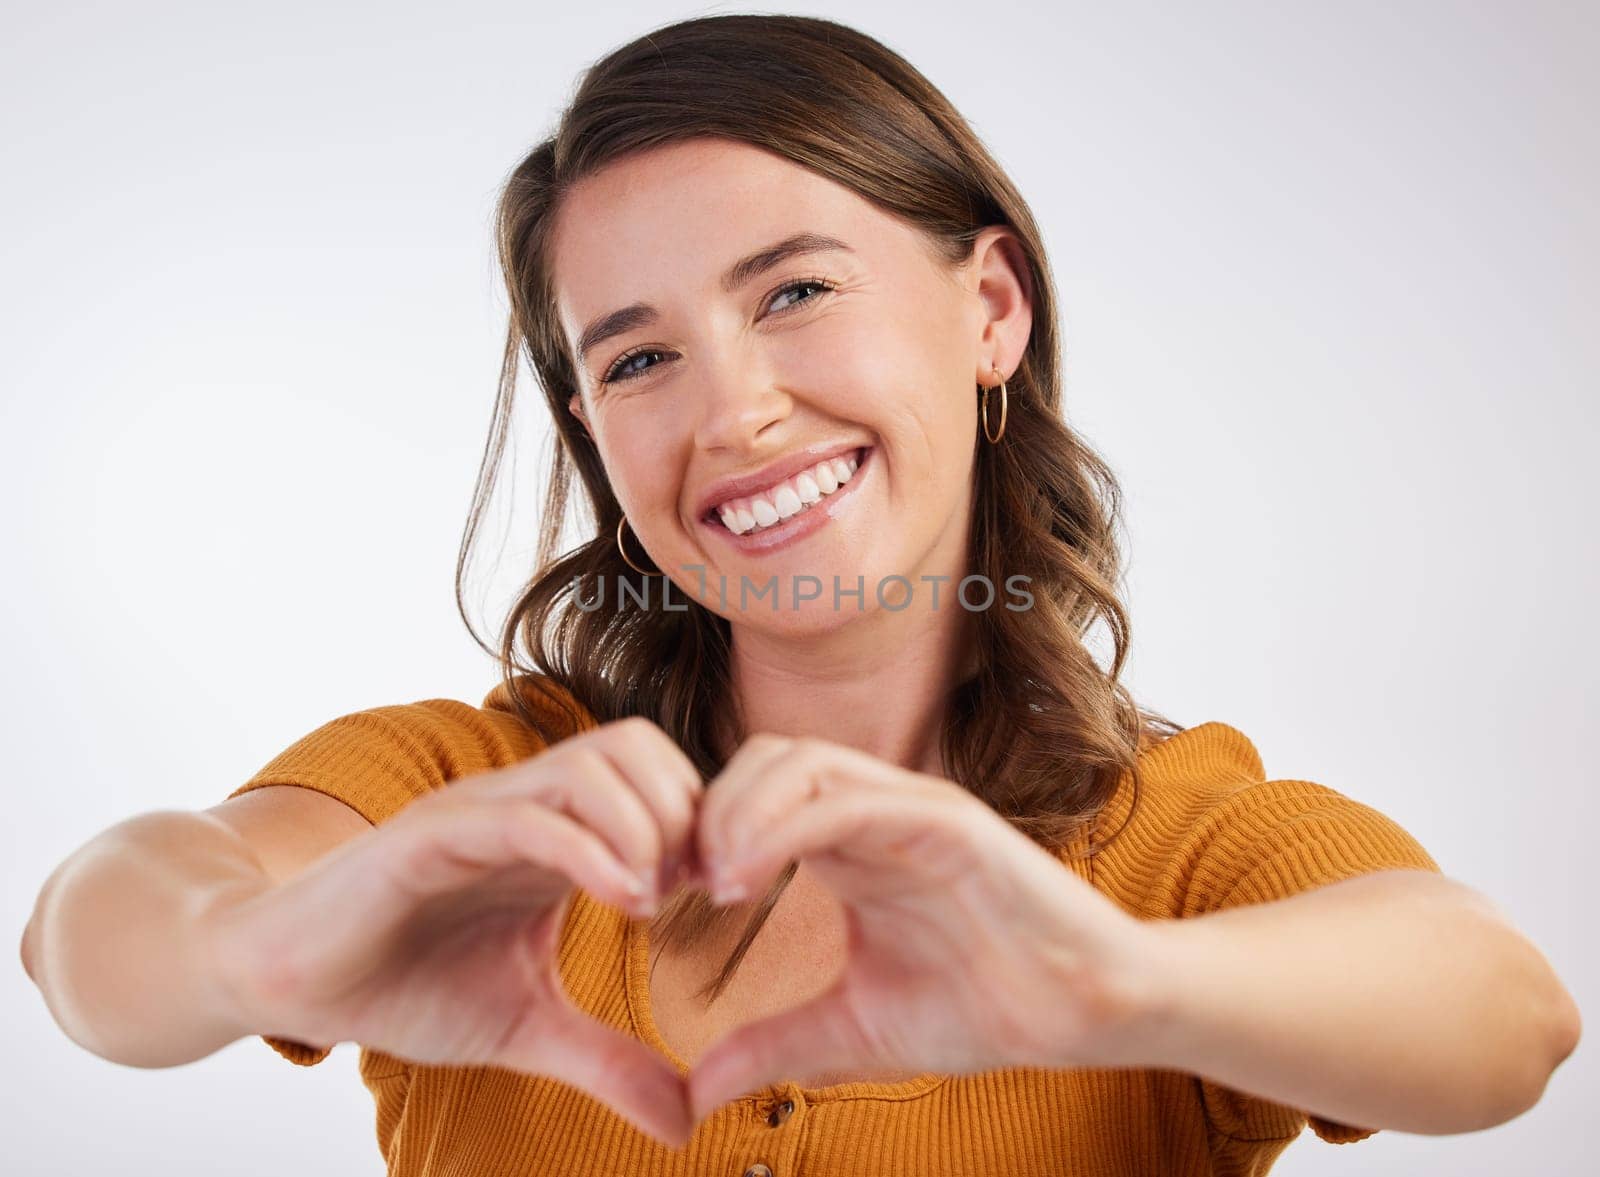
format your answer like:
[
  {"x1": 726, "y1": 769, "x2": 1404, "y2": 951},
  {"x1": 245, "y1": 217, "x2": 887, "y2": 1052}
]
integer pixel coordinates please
[{"x1": 222, "y1": 684, "x2": 1440, "y2": 1177}]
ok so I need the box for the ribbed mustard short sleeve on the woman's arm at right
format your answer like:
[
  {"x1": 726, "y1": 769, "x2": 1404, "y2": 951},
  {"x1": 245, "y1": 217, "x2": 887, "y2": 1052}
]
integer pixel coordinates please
[{"x1": 1184, "y1": 780, "x2": 1442, "y2": 1143}]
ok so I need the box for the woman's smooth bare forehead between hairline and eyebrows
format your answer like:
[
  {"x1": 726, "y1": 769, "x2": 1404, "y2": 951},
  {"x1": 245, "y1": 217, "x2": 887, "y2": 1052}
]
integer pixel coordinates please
[{"x1": 550, "y1": 139, "x2": 909, "y2": 339}]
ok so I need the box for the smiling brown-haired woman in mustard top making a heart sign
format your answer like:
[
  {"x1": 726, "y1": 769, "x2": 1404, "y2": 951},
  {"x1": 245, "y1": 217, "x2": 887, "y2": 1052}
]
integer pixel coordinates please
[{"x1": 22, "y1": 14, "x2": 1579, "y2": 1177}]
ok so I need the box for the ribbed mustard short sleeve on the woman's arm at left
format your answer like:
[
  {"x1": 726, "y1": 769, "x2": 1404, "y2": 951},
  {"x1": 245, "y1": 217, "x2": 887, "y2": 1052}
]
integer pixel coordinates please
[{"x1": 229, "y1": 680, "x2": 592, "y2": 1067}]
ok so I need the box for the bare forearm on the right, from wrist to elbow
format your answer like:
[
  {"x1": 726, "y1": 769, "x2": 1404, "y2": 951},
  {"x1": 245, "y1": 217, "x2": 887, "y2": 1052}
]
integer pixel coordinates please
[{"x1": 1130, "y1": 872, "x2": 1579, "y2": 1134}]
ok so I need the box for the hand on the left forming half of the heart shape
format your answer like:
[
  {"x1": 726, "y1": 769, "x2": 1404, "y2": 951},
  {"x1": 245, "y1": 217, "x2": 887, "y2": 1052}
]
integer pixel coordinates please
[{"x1": 208, "y1": 720, "x2": 702, "y2": 1145}]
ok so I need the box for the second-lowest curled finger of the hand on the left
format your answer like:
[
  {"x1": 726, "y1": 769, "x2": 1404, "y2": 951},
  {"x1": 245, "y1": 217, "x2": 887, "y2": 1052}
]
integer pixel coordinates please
[{"x1": 478, "y1": 745, "x2": 662, "y2": 884}]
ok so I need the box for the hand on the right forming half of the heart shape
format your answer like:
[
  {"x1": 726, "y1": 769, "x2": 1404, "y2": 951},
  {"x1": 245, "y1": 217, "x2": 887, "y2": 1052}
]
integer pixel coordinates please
[{"x1": 690, "y1": 734, "x2": 1158, "y2": 1123}]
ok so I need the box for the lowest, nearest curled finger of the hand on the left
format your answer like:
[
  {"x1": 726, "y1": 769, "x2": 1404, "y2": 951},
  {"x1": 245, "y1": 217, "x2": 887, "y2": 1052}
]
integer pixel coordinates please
[{"x1": 384, "y1": 798, "x2": 645, "y2": 913}]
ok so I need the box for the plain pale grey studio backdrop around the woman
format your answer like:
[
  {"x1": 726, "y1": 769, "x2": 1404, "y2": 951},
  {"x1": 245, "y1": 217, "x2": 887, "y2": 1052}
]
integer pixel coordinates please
[{"x1": 0, "y1": 0, "x2": 1600, "y2": 1177}]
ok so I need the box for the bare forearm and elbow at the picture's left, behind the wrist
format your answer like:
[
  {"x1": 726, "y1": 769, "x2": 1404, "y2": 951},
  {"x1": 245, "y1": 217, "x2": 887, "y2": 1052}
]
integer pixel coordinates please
[{"x1": 22, "y1": 811, "x2": 270, "y2": 1067}]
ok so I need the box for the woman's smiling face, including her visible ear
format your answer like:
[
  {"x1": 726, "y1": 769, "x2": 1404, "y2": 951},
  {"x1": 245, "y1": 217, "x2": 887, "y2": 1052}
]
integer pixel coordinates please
[{"x1": 552, "y1": 139, "x2": 1030, "y2": 633}]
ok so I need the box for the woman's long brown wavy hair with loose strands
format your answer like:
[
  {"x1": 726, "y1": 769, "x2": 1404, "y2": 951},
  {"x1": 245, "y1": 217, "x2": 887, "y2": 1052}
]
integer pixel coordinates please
[{"x1": 456, "y1": 14, "x2": 1182, "y2": 1001}]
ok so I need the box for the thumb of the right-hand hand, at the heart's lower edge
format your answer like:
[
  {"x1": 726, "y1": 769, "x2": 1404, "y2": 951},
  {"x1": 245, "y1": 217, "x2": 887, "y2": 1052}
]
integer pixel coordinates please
[{"x1": 688, "y1": 979, "x2": 883, "y2": 1123}]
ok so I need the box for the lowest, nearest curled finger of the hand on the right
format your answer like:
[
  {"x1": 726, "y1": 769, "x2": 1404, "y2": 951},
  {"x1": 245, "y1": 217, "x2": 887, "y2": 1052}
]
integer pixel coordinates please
[{"x1": 710, "y1": 790, "x2": 965, "y2": 894}]
